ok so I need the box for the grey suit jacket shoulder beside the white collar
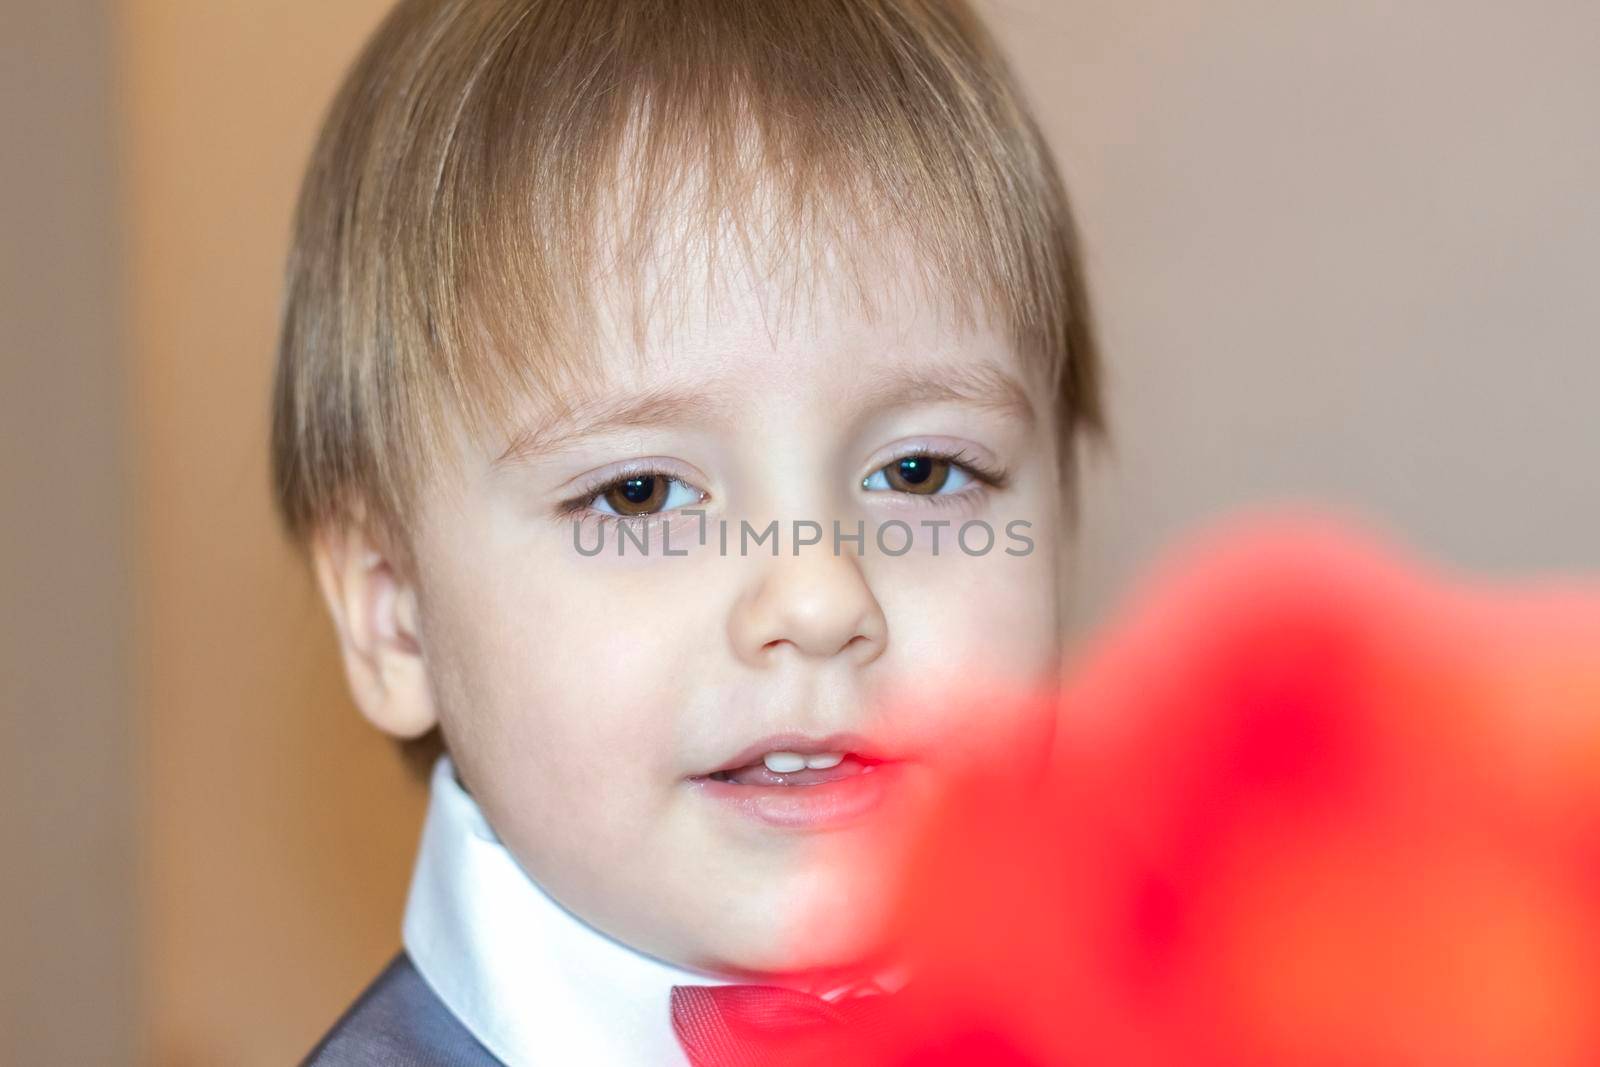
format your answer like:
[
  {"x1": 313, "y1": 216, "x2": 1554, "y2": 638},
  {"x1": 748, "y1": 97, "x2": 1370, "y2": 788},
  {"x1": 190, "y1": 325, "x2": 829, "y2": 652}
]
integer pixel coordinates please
[{"x1": 301, "y1": 952, "x2": 504, "y2": 1067}]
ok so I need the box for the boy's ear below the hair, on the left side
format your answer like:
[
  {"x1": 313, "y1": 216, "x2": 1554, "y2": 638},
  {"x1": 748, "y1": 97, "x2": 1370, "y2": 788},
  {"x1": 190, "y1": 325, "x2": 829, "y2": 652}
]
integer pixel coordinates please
[{"x1": 312, "y1": 526, "x2": 438, "y2": 737}]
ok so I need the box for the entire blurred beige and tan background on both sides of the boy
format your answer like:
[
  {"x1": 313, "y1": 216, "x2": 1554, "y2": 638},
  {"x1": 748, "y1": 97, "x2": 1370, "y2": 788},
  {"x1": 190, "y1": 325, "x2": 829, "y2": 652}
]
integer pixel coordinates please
[{"x1": 0, "y1": 0, "x2": 1600, "y2": 1065}]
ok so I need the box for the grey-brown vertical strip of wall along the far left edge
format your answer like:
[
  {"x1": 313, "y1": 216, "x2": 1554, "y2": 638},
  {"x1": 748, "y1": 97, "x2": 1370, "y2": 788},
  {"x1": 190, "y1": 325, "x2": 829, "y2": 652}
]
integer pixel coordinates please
[{"x1": 0, "y1": 0, "x2": 138, "y2": 1065}]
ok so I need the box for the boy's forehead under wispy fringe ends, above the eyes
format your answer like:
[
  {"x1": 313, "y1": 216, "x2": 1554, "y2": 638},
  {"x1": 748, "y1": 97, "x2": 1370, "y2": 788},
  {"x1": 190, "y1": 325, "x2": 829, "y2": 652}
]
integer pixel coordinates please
[{"x1": 502, "y1": 233, "x2": 1048, "y2": 458}]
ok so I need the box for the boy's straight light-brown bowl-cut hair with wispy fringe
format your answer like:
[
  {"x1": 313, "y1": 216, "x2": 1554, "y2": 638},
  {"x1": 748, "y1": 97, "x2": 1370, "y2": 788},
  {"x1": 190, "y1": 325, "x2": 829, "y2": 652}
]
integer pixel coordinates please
[{"x1": 272, "y1": 0, "x2": 1101, "y2": 553}]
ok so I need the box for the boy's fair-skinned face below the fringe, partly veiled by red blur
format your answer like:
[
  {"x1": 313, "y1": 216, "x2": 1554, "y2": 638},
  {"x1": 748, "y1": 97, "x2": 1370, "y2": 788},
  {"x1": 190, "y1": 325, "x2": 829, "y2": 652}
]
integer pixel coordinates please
[{"x1": 332, "y1": 254, "x2": 1062, "y2": 973}]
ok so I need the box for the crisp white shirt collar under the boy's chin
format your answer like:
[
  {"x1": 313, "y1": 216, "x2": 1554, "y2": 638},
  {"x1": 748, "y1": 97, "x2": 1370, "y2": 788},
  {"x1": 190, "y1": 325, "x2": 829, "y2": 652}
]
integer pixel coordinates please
[{"x1": 403, "y1": 757, "x2": 728, "y2": 1067}]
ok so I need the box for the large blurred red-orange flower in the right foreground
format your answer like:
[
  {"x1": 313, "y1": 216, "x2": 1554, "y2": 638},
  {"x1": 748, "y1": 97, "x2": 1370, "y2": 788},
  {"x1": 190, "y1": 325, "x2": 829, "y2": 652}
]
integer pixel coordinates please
[{"x1": 774, "y1": 518, "x2": 1600, "y2": 1067}]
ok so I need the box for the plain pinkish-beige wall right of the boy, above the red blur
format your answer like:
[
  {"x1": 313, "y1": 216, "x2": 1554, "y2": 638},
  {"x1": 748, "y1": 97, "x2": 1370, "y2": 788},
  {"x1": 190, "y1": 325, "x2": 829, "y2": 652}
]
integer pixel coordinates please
[{"x1": 990, "y1": 0, "x2": 1600, "y2": 619}]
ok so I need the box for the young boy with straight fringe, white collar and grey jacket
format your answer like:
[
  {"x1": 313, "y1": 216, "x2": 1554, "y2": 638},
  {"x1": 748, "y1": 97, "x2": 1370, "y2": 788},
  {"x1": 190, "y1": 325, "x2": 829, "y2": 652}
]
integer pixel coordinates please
[{"x1": 274, "y1": 0, "x2": 1099, "y2": 1064}]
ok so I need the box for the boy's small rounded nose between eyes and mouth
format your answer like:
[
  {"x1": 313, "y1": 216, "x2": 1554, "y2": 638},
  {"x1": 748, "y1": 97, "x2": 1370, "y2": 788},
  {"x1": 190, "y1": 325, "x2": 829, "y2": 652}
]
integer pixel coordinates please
[{"x1": 728, "y1": 545, "x2": 888, "y2": 667}]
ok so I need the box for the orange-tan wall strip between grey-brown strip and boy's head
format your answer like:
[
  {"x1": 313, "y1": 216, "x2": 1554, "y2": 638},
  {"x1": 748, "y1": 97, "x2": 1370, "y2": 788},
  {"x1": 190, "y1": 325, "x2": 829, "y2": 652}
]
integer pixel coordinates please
[{"x1": 118, "y1": 0, "x2": 419, "y2": 1067}]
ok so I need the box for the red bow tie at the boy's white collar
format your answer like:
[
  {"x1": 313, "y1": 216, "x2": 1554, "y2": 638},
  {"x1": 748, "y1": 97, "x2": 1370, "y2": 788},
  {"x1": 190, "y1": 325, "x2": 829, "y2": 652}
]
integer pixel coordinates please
[{"x1": 672, "y1": 985, "x2": 891, "y2": 1067}]
